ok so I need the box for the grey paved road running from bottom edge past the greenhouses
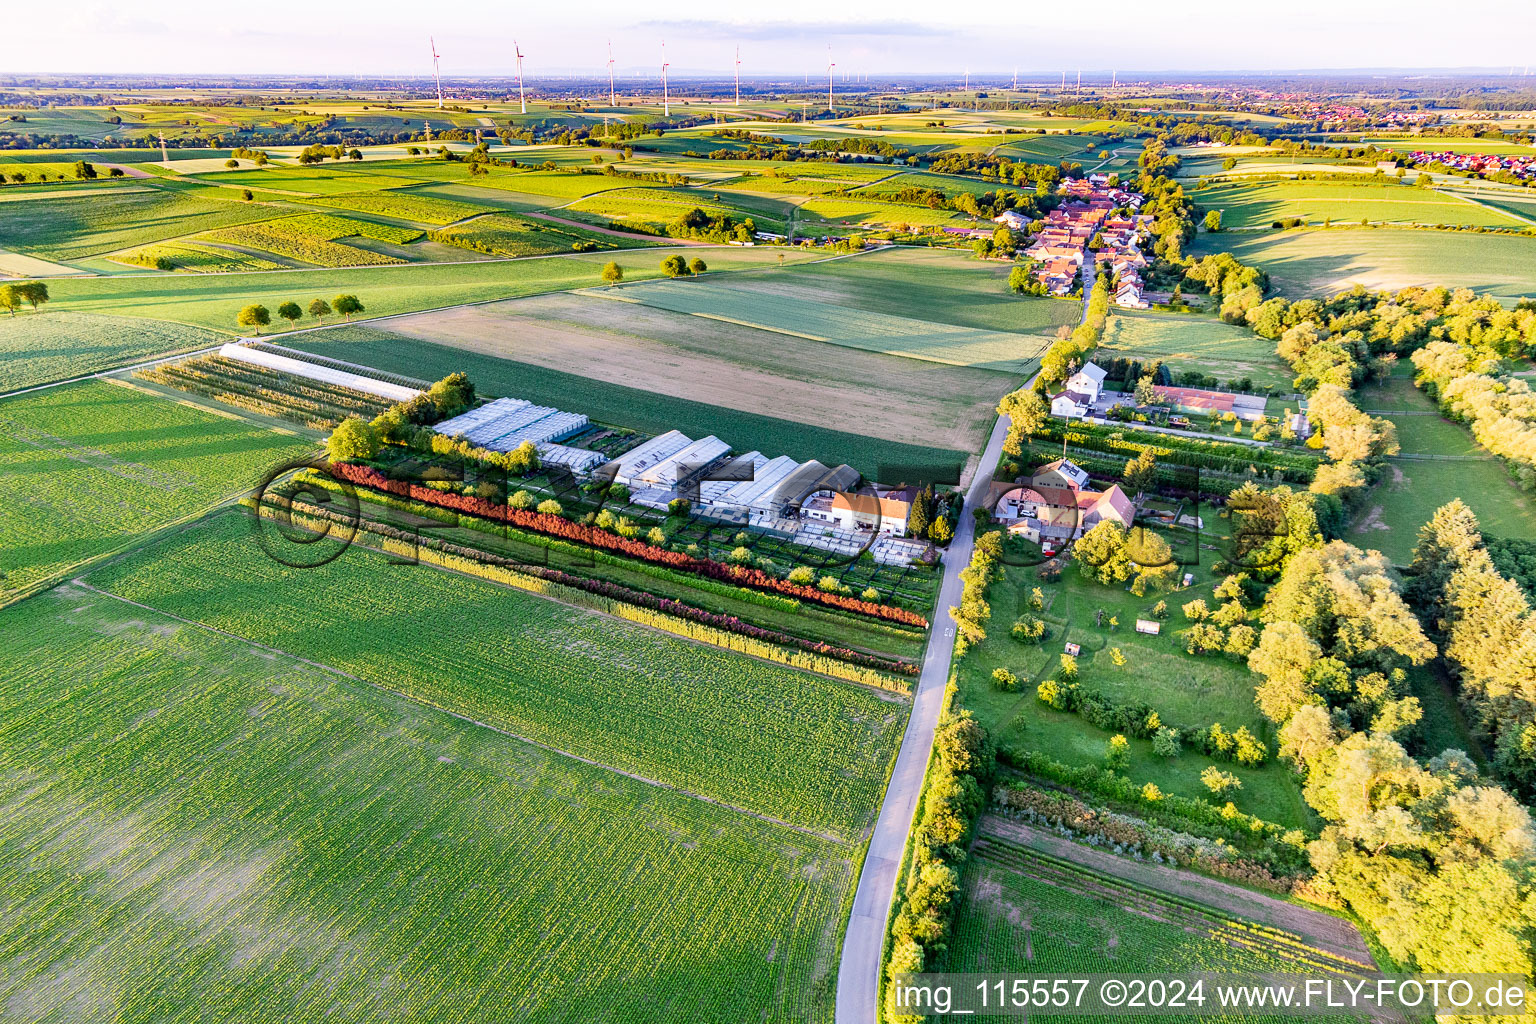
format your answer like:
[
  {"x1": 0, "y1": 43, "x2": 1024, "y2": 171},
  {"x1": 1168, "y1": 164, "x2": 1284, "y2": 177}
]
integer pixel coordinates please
[{"x1": 837, "y1": 416, "x2": 1009, "y2": 1024}]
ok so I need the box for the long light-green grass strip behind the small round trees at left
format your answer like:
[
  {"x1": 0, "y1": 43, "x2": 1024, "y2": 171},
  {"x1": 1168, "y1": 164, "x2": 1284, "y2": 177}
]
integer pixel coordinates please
[{"x1": 49, "y1": 247, "x2": 825, "y2": 330}]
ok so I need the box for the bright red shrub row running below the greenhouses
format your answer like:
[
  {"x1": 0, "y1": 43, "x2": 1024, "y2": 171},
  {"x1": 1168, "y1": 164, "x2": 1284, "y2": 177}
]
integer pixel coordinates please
[{"x1": 330, "y1": 462, "x2": 928, "y2": 628}]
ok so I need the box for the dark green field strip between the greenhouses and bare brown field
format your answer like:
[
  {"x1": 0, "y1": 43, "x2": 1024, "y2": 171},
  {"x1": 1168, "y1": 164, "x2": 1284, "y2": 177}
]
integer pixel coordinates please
[{"x1": 283, "y1": 327, "x2": 969, "y2": 479}]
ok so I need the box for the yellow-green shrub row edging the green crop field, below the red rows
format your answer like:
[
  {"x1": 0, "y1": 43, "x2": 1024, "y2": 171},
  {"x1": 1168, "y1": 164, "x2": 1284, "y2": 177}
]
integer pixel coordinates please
[{"x1": 252, "y1": 502, "x2": 917, "y2": 694}]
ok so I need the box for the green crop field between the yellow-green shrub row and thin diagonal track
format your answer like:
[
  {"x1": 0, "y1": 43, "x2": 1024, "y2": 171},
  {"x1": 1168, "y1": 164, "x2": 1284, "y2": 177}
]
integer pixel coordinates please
[{"x1": 88, "y1": 510, "x2": 906, "y2": 840}]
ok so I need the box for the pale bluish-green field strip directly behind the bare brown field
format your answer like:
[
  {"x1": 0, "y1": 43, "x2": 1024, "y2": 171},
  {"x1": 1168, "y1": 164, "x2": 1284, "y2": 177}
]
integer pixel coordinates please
[{"x1": 588, "y1": 275, "x2": 1049, "y2": 376}]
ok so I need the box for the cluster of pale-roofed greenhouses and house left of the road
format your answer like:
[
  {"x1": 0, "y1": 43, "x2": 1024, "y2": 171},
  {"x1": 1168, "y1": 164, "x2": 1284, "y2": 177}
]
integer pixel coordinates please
[{"x1": 433, "y1": 398, "x2": 923, "y2": 557}]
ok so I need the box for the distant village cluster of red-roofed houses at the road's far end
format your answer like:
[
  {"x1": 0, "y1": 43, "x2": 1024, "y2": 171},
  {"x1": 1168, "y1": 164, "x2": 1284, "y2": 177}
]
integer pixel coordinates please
[{"x1": 997, "y1": 173, "x2": 1152, "y2": 309}]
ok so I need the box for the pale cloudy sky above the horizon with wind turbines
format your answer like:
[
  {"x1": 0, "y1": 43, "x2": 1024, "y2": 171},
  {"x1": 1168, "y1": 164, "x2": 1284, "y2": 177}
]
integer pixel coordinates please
[{"x1": 12, "y1": 0, "x2": 1536, "y2": 83}]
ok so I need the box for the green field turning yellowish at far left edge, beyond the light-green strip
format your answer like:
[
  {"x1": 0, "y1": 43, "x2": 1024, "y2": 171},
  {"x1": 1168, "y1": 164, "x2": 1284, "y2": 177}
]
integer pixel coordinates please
[{"x1": 0, "y1": 187, "x2": 272, "y2": 259}]
